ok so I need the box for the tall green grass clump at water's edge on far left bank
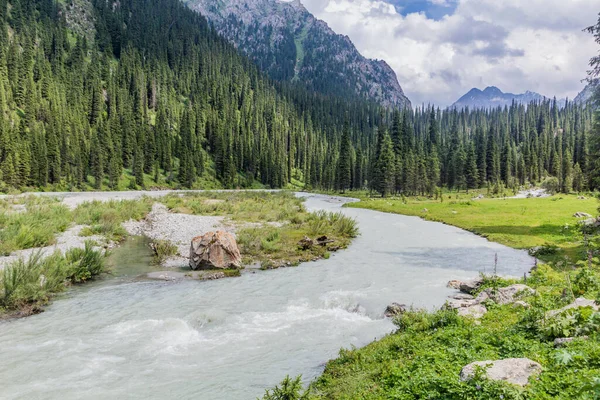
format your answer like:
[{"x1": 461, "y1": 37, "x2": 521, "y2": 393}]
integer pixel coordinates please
[{"x1": 0, "y1": 242, "x2": 105, "y2": 318}]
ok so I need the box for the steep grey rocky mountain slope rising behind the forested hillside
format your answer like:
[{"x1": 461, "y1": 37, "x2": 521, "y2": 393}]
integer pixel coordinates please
[{"x1": 184, "y1": 0, "x2": 410, "y2": 107}]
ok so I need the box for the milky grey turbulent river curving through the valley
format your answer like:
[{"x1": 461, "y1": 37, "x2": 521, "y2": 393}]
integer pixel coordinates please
[{"x1": 0, "y1": 196, "x2": 533, "y2": 400}]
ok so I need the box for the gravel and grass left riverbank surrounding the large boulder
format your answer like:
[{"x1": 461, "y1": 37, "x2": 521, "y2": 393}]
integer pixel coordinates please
[{"x1": 0, "y1": 191, "x2": 358, "y2": 316}]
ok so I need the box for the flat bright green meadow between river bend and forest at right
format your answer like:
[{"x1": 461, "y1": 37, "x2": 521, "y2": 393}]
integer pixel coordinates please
[{"x1": 347, "y1": 194, "x2": 598, "y2": 261}]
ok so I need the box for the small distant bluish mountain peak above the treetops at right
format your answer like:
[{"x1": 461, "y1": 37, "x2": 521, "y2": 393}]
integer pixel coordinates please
[{"x1": 450, "y1": 86, "x2": 545, "y2": 109}]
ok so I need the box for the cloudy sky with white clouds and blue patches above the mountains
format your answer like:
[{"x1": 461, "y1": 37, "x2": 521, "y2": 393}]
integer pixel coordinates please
[{"x1": 301, "y1": 0, "x2": 600, "y2": 106}]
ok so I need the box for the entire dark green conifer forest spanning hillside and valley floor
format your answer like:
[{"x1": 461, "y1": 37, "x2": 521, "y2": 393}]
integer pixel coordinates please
[{"x1": 0, "y1": 0, "x2": 600, "y2": 195}]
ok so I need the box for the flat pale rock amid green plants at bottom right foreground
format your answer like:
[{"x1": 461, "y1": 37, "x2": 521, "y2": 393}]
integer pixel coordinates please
[{"x1": 460, "y1": 358, "x2": 542, "y2": 386}]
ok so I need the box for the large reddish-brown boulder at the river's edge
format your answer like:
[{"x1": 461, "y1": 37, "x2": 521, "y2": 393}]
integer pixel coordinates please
[{"x1": 190, "y1": 231, "x2": 242, "y2": 270}]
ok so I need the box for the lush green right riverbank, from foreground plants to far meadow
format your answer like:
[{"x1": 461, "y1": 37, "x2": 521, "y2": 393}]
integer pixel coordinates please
[{"x1": 264, "y1": 195, "x2": 600, "y2": 399}]
